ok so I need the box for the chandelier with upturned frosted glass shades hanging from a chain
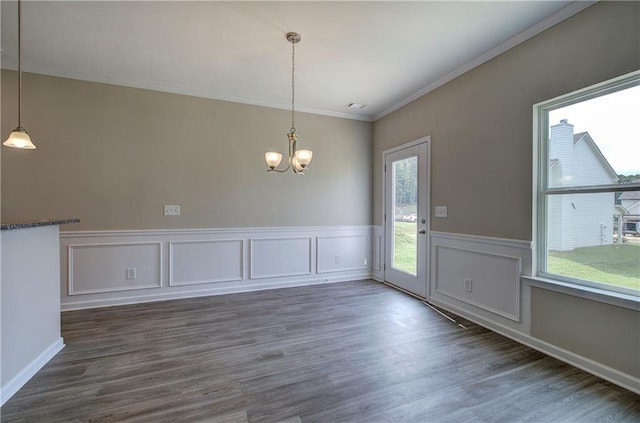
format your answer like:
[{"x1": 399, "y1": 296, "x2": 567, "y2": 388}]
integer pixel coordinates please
[{"x1": 264, "y1": 32, "x2": 313, "y2": 175}]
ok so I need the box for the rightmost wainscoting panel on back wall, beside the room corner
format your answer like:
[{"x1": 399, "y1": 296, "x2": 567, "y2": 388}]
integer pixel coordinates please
[{"x1": 316, "y1": 235, "x2": 370, "y2": 273}]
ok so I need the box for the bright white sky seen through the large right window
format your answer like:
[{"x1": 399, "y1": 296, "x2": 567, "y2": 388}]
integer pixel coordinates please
[{"x1": 549, "y1": 86, "x2": 640, "y2": 175}]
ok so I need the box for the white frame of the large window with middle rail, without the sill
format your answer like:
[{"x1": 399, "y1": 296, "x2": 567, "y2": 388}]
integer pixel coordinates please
[{"x1": 532, "y1": 71, "x2": 640, "y2": 302}]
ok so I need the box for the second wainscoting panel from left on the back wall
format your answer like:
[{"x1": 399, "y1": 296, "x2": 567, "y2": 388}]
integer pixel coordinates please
[{"x1": 169, "y1": 239, "x2": 244, "y2": 286}]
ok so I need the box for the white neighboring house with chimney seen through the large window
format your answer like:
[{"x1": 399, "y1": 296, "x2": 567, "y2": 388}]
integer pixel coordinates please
[{"x1": 548, "y1": 119, "x2": 620, "y2": 251}]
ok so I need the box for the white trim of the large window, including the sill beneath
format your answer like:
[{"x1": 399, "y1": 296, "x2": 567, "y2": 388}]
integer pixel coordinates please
[{"x1": 527, "y1": 71, "x2": 640, "y2": 309}]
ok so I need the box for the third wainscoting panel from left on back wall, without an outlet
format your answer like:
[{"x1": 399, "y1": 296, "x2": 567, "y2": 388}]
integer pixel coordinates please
[{"x1": 251, "y1": 237, "x2": 312, "y2": 279}]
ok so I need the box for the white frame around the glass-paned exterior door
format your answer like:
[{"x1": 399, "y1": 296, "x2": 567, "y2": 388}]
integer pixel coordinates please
[{"x1": 380, "y1": 135, "x2": 431, "y2": 300}]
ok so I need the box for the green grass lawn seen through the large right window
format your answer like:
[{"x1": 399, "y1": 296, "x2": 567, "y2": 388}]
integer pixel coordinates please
[{"x1": 547, "y1": 243, "x2": 640, "y2": 289}]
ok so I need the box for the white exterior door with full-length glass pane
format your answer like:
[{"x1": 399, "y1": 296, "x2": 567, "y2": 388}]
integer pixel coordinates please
[{"x1": 384, "y1": 137, "x2": 429, "y2": 298}]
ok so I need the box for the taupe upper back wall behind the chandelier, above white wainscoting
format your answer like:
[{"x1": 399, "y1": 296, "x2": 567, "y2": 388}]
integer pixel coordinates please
[{"x1": 2, "y1": 71, "x2": 372, "y2": 230}]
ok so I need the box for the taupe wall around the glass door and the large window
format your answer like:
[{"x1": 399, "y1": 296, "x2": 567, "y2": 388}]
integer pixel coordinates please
[{"x1": 373, "y1": 2, "x2": 640, "y2": 377}]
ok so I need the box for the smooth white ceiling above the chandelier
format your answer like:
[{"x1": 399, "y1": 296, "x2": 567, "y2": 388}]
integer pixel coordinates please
[{"x1": 1, "y1": 0, "x2": 591, "y2": 121}]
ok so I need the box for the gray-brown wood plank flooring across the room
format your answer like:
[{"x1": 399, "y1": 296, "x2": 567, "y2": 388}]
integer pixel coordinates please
[{"x1": 1, "y1": 281, "x2": 640, "y2": 423}]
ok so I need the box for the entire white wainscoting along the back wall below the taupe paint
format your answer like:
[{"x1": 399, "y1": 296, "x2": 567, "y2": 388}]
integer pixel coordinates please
[{"x1": 60, "y1": 226, "x2": 372, "y2": 311}]
